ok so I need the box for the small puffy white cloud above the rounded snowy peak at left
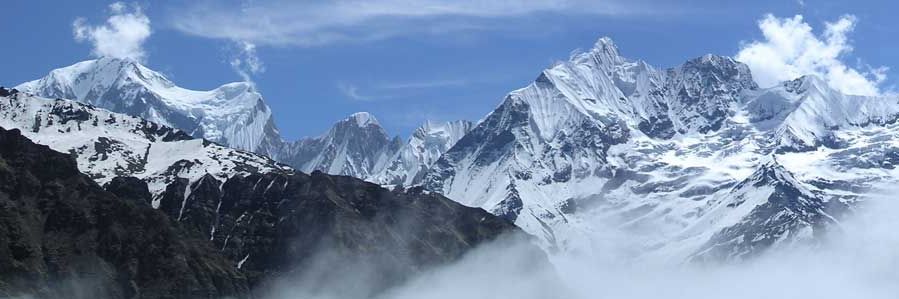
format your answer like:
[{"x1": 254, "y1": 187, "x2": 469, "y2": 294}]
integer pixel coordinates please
[{"x1": 72, "y1": 2, "x2": 152, "y2": 60}]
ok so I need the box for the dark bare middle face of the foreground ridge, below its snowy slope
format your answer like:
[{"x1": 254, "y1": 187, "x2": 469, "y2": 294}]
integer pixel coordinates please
[{"x1": 157, "y1": 171, "x2": 524, "y2": 288}]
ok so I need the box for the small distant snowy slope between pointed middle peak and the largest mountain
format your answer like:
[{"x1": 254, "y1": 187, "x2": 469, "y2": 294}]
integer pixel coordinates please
[{"x1": 367, "y1": 120, "x2": 473, "y2": 186}]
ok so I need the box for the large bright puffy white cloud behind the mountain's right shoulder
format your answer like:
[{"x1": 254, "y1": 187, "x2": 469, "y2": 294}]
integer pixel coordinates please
[{"x1": 736, "y1": 15, "x2": 887, "y2": 95}]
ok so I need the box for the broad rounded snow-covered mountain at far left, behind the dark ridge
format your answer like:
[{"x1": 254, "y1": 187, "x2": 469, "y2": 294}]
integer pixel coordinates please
[{"x1": 16, "y1": 57, "x2": 280, "y2": 154}]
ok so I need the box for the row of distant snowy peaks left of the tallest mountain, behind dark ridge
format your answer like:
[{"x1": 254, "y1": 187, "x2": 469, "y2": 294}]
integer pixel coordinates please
[{"x1": 16, "y1": 61, "x2": 471, "y2": 185}]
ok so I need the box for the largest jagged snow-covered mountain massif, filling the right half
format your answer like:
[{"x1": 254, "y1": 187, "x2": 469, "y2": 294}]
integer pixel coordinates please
[{"x1": 423, "y1": 38, "x2": 899, "y2": 260}]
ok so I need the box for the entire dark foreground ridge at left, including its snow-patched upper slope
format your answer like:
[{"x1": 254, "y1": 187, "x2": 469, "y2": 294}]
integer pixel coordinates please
[{"x1": 0, "y1": 89, "x2": 545, "y2": 298}]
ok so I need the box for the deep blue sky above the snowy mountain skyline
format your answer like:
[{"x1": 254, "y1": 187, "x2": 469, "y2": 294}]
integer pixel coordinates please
[{"x1": 0, "y1": 0, "x2": 899, "y2": 139}]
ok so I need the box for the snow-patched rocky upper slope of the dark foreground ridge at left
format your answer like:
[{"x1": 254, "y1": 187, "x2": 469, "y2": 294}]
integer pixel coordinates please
[{"x1": 0, "y1": 88, "x2": 290, "y2": 205}]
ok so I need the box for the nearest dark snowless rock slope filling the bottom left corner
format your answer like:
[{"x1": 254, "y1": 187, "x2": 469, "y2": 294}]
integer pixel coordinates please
[{"x1": 0, "y1": 129, "x2": 248, "y2": 298}]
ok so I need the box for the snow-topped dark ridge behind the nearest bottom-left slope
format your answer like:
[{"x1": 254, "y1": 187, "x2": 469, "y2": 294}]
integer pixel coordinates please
[{"x1": 0, "y1": 89, "x2": 545, "y2": 297}]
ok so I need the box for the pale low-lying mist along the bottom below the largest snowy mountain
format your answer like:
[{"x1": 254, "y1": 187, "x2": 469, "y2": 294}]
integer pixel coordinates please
[{"x1": 265, "y1": 189, "x2": 899, "y2": 299}]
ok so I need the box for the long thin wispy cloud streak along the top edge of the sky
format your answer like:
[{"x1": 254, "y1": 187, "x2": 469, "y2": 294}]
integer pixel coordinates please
[{"x1": 171, "y1": 0, "x2": 675, "y2": 47}]
